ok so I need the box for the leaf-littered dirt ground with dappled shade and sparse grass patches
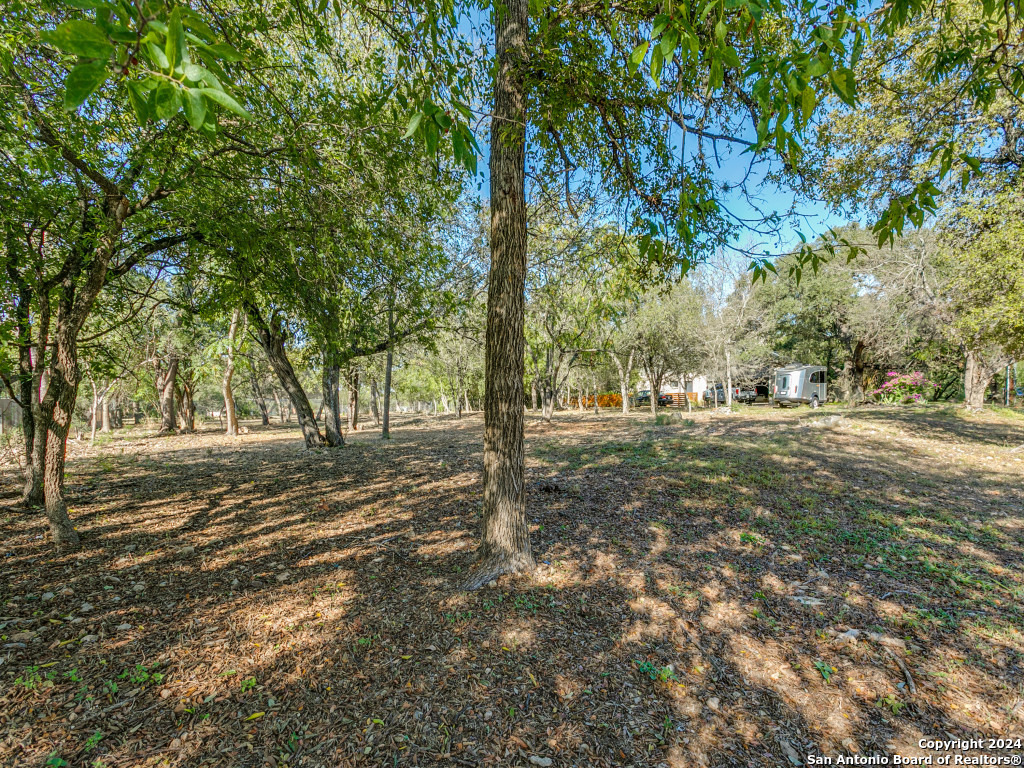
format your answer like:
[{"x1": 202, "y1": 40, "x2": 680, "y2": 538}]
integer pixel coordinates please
[{"x1": 0, "y1": 407, "x2": 1024, "y2": 768}]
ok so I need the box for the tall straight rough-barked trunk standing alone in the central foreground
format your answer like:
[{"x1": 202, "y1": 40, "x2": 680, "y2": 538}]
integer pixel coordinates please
[{"x1": 464, "y1": 0, "x2": 535, "y2": 589}]
